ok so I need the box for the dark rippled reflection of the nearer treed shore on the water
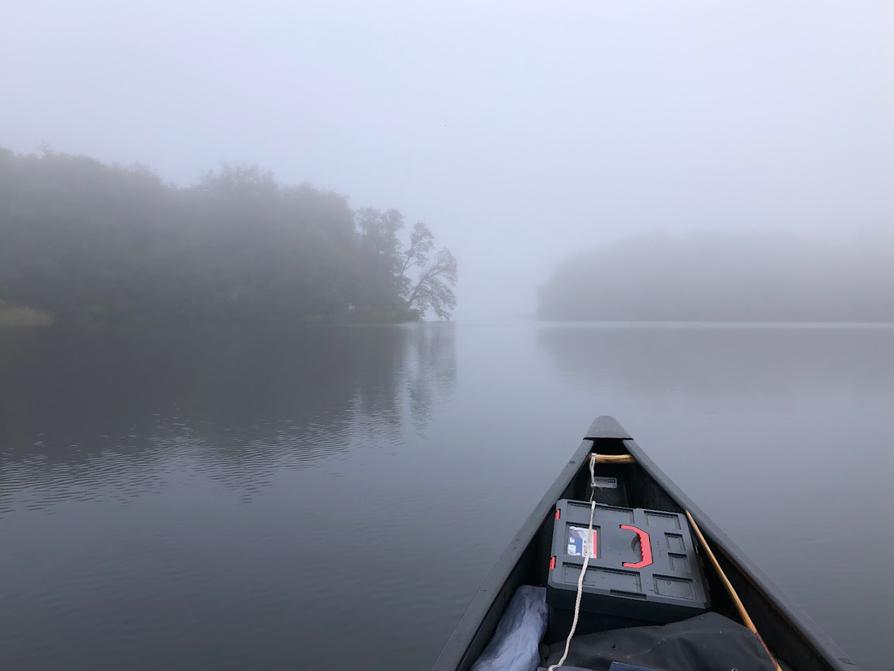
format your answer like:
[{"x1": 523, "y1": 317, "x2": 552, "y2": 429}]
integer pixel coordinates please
[{"x1": 0, "y1": 324, "x2": 456, "y2": 513}]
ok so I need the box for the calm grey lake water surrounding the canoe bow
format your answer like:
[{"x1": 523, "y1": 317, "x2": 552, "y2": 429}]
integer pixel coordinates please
[{"x1": 0, "y1": 323, "x2": 894, "y2": 671}]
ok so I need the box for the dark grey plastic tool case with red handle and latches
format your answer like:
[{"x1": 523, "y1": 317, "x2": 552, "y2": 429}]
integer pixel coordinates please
[{"x1": 547, "y1": 499, "x2": 709, "y2": 633}]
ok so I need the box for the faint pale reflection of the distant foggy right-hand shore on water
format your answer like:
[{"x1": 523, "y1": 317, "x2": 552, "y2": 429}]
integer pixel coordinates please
[{"x1": 537, "y1": 324, "x2": 894, "y2": 399}]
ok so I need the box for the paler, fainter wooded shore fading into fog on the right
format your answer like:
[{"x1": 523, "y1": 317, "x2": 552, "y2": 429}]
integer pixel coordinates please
[{"x1": 538, "y1": 231, "x2": 894, "y2": 322}]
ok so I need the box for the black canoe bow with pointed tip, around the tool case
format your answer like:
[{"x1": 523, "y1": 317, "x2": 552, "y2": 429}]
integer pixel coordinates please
[{"x1": 432, "y1": 417, "x2": 858, "y2": 671}]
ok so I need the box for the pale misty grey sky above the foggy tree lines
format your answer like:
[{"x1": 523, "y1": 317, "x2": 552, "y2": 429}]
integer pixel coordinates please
[{"x1": 0, "y1": 0, "x2": 894, "y2": 320}]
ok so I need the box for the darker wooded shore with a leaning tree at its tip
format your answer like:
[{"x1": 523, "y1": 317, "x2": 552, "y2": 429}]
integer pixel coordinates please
[{"x1": 0, "y1": 148, "x2": 457, "y2": 324}]
